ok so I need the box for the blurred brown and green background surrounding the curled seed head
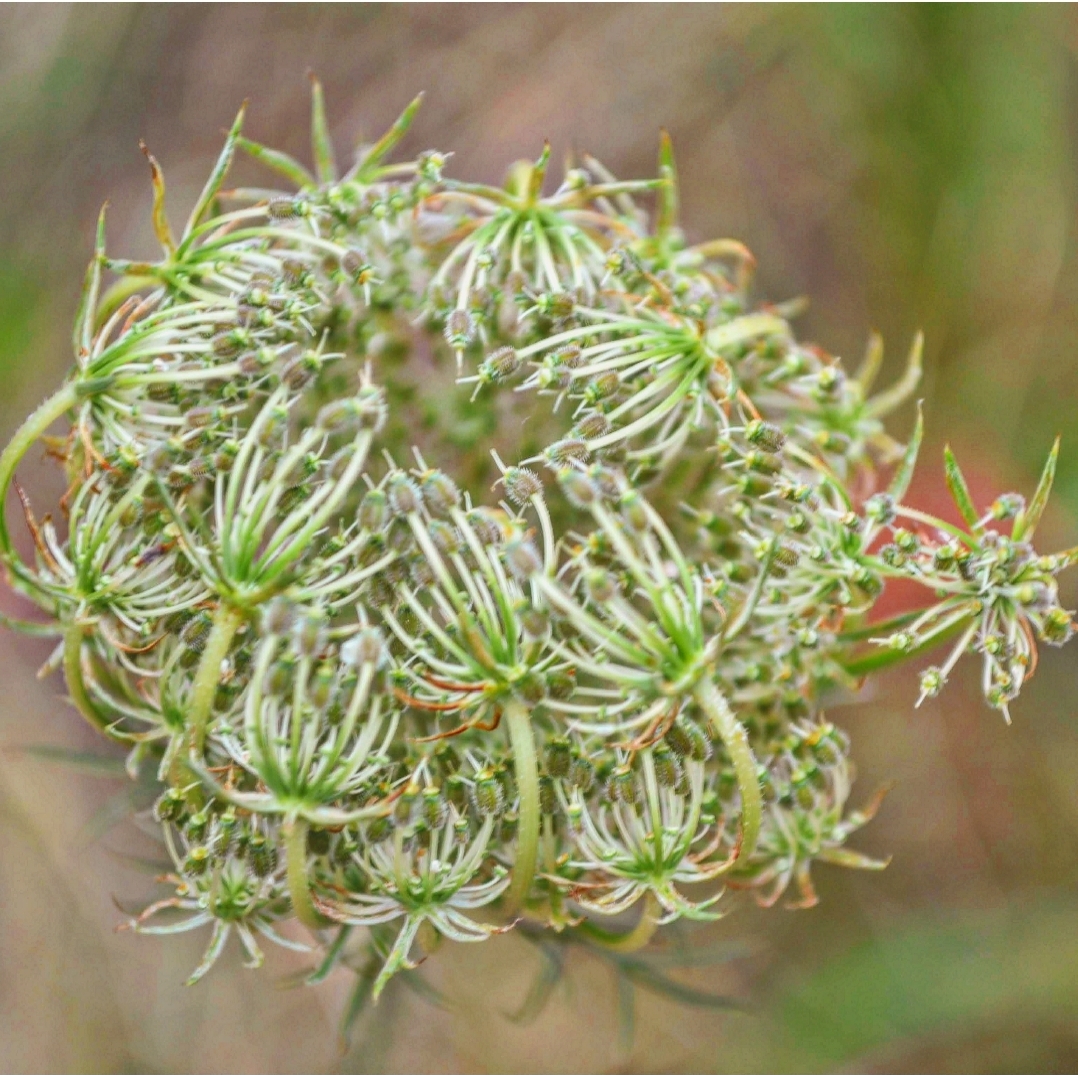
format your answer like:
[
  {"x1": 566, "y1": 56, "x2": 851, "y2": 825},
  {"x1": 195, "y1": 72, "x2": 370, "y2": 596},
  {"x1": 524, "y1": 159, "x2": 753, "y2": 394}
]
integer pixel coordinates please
[{"x1": 0, "y1": 4, "x2": 1078, "y2": 1073}]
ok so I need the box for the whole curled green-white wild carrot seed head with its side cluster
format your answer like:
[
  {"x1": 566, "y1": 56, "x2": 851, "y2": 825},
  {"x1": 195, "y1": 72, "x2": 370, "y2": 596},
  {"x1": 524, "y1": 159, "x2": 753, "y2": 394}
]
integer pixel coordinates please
[{"x1": 0, "y1": 89, "x2": 1078, "y2": 989}]
